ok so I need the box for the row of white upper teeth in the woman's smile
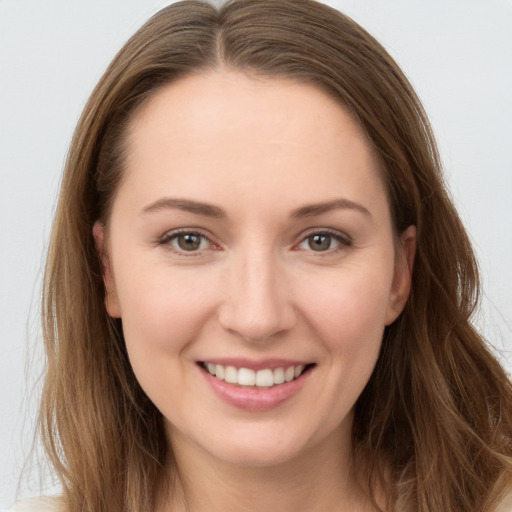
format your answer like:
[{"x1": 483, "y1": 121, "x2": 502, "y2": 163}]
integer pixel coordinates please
[{"x1": 204, "y1": 363, "x2": 305, "y2": 388}]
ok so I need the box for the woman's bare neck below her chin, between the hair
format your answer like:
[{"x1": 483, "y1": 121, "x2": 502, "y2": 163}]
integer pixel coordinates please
[{"x1": 162, "y1": 424, "x2": 370, "y2": 512}]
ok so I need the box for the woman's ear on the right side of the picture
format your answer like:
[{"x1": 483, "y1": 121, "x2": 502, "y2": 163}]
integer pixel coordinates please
[{"x1": 386, "y1": 226, "x2": 416, "y2": 325}]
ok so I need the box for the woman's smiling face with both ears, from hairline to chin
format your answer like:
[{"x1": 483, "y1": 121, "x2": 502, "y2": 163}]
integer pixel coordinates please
[{"x1": 94, "y1": 71, "x2": 414, "y2": 465}]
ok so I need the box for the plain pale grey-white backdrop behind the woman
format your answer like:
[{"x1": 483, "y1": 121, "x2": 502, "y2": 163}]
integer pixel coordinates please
[{"x1": 0, "y1": 0, "x2": 512, "y2": 508}]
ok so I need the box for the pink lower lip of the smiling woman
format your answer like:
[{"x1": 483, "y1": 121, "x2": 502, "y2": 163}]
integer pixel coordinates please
[{"x1": 200, "y1": 369, "x2": 311, "y2": 412}]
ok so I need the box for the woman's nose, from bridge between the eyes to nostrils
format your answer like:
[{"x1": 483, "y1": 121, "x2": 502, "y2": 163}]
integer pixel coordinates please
[{"x1": 219, "y1": 250, "x2": 296, "y2": 342}]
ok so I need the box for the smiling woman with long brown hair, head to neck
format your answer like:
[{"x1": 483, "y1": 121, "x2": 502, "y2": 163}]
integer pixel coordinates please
[{"x1": 8, "y1": 0, "x2": 512, "y2": 512}]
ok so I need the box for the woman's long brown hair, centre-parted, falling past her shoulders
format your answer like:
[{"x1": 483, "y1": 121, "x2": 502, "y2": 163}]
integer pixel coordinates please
[{"x1": 40, "y1": 0, "x2": 512, "y2": 512}]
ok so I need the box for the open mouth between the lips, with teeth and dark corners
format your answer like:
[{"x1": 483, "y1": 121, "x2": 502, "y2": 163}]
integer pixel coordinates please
[{"x1": 197, "y1": 361, "x2": 315, "y2": 389}]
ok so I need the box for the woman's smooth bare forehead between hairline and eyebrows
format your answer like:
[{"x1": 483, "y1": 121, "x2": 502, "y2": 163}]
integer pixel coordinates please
[{"x1": 117, "y1": 70, "x2": 383, "y2": 218}]
